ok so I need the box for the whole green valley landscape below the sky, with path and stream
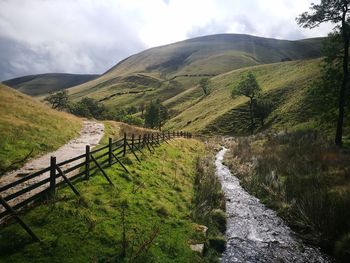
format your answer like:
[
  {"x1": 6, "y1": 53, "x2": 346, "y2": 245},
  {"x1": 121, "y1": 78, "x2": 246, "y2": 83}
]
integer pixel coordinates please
[{"x1": 0, "y1": 28, "x2": 350, "y2": 262}]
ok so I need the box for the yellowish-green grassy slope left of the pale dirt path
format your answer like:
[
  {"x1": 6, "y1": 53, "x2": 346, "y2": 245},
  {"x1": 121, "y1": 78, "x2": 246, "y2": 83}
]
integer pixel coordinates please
[{"x1": 0, "y1": 84, "x2": 82, "y2": 174}]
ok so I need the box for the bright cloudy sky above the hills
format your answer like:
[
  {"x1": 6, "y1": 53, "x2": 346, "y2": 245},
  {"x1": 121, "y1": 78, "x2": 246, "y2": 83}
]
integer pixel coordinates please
[{"x1": 0, "y1": 0, "x2": 333, "y2": 81}]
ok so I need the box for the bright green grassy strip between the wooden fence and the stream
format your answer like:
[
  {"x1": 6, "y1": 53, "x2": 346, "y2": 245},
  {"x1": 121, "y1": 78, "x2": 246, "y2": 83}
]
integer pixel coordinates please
[{"x1": 0, "y1": 139, "x2": 204, "y2": 262}]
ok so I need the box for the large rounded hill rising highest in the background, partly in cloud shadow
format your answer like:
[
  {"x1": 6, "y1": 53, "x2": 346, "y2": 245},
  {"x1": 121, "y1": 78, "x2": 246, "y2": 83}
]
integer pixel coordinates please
[{"x1": 69, "y1": 34, "x2": 322, "y2": 111}]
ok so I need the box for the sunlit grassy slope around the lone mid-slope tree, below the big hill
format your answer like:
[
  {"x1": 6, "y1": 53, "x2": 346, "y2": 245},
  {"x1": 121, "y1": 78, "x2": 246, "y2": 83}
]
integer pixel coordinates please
[{"x1": 166, "y1": 59, "x2": 320, "y2": 133}]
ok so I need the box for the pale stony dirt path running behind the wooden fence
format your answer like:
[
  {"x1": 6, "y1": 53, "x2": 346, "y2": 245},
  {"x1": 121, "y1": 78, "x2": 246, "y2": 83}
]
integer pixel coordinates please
[{"x1": 0, "y1": 121, "x2": 104, "y2": 212}]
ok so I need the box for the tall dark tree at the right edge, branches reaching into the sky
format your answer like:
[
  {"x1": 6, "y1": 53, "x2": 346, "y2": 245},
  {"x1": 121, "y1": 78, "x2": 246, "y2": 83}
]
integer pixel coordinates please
[{"x1": 296, "y1": 0, "x2": 350, "y2": 146}]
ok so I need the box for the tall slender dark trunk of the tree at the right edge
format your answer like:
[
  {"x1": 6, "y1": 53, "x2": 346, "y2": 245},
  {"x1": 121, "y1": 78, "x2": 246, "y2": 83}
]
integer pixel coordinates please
[{"x1": 335, "y1": 7, "x2": 349, "y2": 146}]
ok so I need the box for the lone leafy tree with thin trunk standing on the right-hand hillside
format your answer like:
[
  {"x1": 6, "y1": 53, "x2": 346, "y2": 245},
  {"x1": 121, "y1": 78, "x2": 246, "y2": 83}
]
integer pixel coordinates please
[{"x1": 231, "y1": 72, "x2": 261, "y2": 126}]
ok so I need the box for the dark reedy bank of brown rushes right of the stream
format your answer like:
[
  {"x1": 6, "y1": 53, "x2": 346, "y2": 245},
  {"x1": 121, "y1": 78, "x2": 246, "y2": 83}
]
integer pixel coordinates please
[{"x1": 226, "y1": 132, "x2": 350, "y2": 262}]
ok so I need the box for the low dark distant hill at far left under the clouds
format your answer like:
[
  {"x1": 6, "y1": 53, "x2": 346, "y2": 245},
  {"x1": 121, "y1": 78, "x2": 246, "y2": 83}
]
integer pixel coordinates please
[{"x1": 3, "y1": 73, "x2": 99, "y2": 96}]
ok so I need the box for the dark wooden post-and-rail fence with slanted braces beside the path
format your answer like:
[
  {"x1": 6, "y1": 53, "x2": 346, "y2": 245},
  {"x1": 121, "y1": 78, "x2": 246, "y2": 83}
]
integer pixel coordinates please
[{"x1": 0, "y1": 131, "x2": 192, "y2": 241}]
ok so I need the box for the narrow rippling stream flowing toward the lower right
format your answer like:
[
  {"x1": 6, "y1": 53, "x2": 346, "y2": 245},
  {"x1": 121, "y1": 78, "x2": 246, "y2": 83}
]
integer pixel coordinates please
[{"x1": 215, "y1": 148, "x2": 331, "y2": 263}]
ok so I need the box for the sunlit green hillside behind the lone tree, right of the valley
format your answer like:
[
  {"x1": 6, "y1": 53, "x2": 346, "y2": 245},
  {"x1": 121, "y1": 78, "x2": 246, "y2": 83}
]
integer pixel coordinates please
[{"x1": 165, "y1": 59, "x2": 320, "y2": 134}]
